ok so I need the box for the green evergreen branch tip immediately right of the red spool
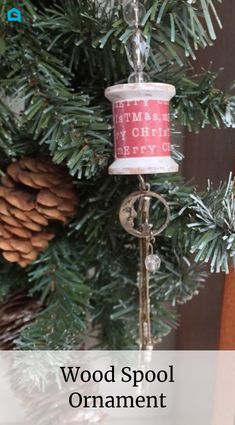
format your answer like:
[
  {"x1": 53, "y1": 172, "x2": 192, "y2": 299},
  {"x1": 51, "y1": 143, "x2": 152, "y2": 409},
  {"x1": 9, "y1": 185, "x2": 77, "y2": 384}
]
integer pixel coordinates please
[{"x1": 151, "y1": 63, "x2": 235, "y2": 133}]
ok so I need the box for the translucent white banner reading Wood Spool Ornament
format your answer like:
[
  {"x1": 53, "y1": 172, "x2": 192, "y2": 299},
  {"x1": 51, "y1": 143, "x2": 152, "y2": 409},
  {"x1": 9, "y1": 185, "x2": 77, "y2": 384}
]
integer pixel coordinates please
[{"x1": 0, "y1": 351, "x2": 235, "y2": 425}]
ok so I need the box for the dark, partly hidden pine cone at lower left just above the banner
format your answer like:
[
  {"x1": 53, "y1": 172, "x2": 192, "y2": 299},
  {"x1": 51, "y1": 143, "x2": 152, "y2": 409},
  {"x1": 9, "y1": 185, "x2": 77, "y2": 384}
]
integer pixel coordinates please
[{"x1": 0, "y1": 292, "x2": 42, "y2": 350}]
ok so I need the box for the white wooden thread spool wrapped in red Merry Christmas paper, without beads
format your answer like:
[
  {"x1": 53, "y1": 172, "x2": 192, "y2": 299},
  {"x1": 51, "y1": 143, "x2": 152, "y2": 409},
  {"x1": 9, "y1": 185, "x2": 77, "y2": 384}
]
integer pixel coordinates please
[{"x1": 106, "y1": 83, "x2": 178, "y2": 174}]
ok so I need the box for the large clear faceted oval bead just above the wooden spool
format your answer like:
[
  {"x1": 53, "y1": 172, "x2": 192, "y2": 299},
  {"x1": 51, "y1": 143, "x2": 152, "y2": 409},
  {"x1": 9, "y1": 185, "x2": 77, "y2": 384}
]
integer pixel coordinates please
[{"x1": 125, "y1": 29, "x2": 149, "y2": 72}]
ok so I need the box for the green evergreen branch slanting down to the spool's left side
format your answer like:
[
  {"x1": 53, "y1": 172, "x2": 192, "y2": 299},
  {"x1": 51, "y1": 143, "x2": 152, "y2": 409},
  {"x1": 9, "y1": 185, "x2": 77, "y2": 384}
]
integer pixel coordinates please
[{"x1": 0, "y1": 20, "x2": 112, "y2": 178}]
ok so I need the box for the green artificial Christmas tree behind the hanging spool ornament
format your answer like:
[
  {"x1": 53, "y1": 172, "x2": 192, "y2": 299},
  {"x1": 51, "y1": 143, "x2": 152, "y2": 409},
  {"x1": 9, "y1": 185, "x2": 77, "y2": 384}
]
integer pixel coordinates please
[{"x1": 0, "y1": 0, "x2": 235, "y2": 349}]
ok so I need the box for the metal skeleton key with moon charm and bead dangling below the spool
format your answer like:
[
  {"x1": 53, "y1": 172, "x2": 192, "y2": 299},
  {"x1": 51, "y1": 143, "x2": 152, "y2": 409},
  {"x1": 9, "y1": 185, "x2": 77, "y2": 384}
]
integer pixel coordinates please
[{"x1": 119, "y1": 176, "x2": 170, "y2": 350}]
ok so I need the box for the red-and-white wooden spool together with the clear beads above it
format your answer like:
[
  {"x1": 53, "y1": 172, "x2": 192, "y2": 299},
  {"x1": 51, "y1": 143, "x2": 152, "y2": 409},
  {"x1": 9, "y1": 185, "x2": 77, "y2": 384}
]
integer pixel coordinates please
[{"x1": 105, "y1": 0, "x2": 178, "y2": 174}]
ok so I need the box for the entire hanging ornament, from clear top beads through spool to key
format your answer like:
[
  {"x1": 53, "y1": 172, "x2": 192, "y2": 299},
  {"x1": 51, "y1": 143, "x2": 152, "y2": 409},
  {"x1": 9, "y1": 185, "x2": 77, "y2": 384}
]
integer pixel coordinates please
[{"x1": 105, "y1": 0, "x2": 178, "y2": 350}]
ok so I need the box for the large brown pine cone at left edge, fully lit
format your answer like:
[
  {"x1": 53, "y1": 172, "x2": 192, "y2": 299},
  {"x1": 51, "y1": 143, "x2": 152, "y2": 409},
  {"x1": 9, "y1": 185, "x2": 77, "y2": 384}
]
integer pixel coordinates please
[{"x1": 0, "y1": 158, "x2": 77, "y2": 267}]
